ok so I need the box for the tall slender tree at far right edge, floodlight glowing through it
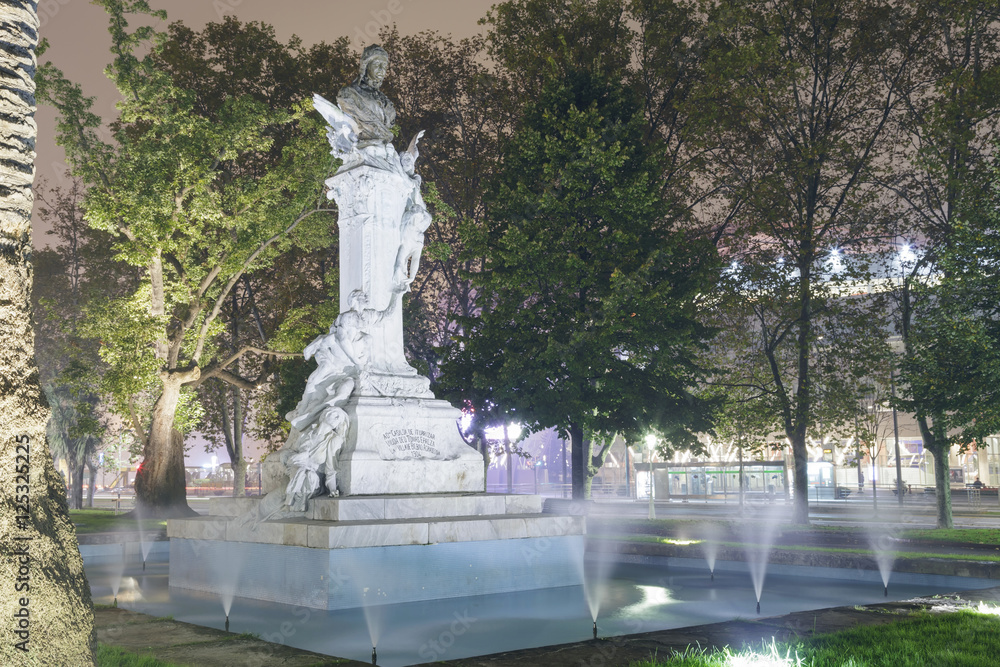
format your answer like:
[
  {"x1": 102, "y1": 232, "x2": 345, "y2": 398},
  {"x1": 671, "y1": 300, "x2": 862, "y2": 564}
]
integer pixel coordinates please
[{"x1": 888, "y1": 0, "x2": 1000, "y2": 528}]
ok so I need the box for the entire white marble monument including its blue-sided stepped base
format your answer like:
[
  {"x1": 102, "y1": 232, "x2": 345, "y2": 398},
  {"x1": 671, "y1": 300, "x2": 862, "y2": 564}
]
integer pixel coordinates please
[{"x1": 167, "y1": 46, "x2": 585, "y2": 609}]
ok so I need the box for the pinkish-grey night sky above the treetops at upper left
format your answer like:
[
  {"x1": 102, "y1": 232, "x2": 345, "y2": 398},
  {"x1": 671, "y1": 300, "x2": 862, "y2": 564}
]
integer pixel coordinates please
[{"x1": 34, "y1": 0, "x2": 496, "y2": 246}]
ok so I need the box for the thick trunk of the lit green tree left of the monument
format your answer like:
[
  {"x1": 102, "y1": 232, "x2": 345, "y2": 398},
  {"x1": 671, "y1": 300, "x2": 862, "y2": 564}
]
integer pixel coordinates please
[{"x1": 134, "y1": 369, "x2": 200, "y2": 518}]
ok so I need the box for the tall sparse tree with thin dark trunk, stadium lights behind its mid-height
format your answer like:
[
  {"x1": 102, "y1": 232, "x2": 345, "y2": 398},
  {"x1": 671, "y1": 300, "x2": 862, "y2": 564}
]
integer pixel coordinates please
[{"x1": 692, "y1": 0, "x2": 917, "y2": 522}]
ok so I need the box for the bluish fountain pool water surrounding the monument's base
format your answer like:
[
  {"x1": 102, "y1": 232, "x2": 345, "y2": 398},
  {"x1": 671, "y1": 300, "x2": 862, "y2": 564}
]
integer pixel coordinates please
[{"x1": 87, "y1": 559, "x2": 996, "y2": 667}]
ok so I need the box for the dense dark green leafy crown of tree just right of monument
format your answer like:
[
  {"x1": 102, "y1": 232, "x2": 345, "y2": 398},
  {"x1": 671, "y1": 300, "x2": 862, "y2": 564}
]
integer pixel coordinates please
[{"x1": 443, "y1": 62, "x2": 714, "y2": 456}]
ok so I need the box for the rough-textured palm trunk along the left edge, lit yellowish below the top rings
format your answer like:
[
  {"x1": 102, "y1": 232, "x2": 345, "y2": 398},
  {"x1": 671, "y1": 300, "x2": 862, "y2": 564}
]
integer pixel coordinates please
[{"x1": 0, "y1": 5, "x2": 97, "y2": 665}]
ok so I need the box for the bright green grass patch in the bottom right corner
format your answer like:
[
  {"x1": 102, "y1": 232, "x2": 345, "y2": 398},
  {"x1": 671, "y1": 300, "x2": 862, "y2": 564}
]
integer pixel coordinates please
[{"x1": 631, "y1": 611, "x2": 1000, "y2": 667}]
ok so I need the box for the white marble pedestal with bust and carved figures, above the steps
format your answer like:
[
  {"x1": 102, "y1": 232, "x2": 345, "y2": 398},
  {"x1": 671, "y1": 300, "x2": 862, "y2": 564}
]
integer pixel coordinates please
[{"x1": 245, "y1": 46, "x2": 483, "y2": 523}]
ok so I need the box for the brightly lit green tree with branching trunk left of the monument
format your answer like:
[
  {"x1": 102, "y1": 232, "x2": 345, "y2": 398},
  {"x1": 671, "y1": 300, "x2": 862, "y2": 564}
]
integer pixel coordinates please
[{"x1": 37, "y1": 0, "x2": 331, "y2": 514}]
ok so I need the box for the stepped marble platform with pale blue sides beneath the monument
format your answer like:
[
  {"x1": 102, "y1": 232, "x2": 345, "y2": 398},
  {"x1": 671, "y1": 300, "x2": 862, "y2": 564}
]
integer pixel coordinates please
[{"x1": 167, "y1": 494, "x2": 586, "y2": 609}]
